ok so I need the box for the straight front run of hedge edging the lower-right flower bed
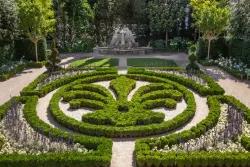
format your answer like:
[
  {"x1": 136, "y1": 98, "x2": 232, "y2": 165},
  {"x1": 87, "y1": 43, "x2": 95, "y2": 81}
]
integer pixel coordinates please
[{"x1": 138, "y1": 151, "x2": 250, "y2": 167}]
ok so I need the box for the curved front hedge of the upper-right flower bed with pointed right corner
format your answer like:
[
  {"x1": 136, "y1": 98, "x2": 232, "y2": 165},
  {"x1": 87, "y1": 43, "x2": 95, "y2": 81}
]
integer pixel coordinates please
[{"x1": 128, "y1": 68, "x2": 225, "y2": 96}]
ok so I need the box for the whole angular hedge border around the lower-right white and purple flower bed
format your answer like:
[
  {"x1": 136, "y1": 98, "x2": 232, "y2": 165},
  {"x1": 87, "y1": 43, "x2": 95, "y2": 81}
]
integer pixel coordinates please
[{"x1": 135, "y1": 95, "x2": 250, "y2": 167}]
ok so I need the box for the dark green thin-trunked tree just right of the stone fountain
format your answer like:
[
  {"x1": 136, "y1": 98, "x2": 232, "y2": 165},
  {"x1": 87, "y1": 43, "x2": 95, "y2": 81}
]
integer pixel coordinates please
[{"x1": 148, "y1": 0, "x2": 188, "y2": 46}]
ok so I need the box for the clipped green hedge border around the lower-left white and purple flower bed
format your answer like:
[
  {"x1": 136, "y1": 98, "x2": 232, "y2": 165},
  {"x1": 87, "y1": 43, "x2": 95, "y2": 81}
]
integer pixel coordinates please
[{"x1": 0, "y1": 96, "x2": 112, "y2": 167}]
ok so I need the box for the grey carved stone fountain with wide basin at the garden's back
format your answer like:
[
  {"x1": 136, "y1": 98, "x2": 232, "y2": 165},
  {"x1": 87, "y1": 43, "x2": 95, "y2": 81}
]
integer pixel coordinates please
[{"x1": 93, "y1": 27, "x2": 153, "y2": 55}]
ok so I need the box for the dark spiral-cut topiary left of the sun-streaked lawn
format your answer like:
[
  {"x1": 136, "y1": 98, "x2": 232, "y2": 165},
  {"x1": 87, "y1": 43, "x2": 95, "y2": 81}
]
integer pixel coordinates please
[{"x1": 45, "y1": 40, "x2": 61, "y2": 72}]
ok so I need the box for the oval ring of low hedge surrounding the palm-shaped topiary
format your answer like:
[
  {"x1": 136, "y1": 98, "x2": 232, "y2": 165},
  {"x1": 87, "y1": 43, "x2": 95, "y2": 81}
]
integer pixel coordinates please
[{"x1": 50, "y1": 75, "x2": 196, "y2": 137}]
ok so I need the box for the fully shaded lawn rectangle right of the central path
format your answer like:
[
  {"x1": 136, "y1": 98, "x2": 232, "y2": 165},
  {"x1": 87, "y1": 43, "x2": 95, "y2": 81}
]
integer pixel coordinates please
[{"x1": 127, "y1": 58, "x2": 178, "y2": 67}]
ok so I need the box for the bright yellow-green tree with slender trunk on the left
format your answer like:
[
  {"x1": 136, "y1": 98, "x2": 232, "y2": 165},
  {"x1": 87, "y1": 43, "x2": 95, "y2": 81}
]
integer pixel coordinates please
[{"x1": 18, "y1": 0, "x2": 56, "y2": 61}]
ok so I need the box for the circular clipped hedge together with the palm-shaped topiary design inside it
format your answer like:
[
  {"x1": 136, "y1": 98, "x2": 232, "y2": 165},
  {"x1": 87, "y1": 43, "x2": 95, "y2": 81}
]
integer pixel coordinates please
[{"x1": 50, "y1": 75, "x2": 196, "y2": 137}]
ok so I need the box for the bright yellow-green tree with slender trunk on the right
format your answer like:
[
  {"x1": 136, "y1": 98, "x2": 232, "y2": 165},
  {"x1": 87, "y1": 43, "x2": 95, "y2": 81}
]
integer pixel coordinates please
[{"x1": 191, "y1": 0, "x2": 231, "y2": 59}]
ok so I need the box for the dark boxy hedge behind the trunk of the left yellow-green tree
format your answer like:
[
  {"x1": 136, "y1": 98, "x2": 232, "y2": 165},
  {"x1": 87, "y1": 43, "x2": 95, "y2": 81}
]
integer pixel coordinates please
[{"x1": 14, "y1": 38, "x2": 47, "y2": 61}]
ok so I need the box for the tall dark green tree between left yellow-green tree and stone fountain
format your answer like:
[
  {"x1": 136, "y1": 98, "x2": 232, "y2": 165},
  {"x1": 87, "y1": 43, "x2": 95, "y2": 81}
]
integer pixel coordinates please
[{"x1": 53, "y1": 0, "x2": 94, "y2": 51}]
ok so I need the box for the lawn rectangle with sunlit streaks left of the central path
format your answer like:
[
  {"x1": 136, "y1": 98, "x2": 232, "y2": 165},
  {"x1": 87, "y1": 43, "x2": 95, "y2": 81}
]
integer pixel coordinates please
[{"x1": 70, "y1": 58, "x2": 119, "y2": 67}]
